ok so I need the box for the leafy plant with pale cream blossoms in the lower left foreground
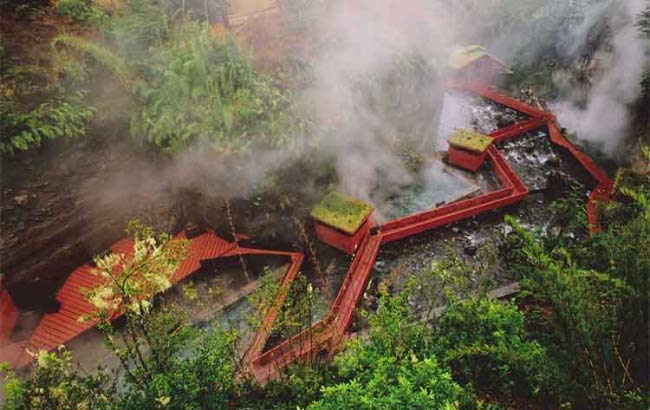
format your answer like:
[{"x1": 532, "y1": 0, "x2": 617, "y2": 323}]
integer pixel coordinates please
[{"x1": 83, "y1": 221, "x2": 243, "y2": 409}]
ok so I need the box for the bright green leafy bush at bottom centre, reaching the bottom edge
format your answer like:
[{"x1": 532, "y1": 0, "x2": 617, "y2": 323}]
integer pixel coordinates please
[{"x1": 310, "y1": 293, "x2": 467, "y2": 409}]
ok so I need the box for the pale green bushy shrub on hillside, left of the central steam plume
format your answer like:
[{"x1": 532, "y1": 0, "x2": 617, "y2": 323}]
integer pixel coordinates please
[{"x1": 131, "y1": 22, "x2": 291, "y2": 154}]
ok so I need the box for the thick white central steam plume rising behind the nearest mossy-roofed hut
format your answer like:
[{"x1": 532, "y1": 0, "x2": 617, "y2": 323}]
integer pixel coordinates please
[{"x1": 303, "y1": 0, "x2": 450, "y2": 205}]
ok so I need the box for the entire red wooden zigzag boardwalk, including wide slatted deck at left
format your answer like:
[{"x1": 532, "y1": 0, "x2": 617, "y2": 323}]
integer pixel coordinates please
[{"x1": 0, "y1": 84, "x2": 613, "y2": 383}]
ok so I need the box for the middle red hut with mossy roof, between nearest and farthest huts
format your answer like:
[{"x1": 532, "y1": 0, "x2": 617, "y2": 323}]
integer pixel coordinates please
[{"x1": 447, "y1": 130, "x2": 494, "y2": 172}]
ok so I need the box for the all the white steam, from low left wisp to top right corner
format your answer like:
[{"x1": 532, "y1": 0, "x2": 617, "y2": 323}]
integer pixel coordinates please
[{"x1": 83, "y1": 0, "x2": 645, "y2": 231}]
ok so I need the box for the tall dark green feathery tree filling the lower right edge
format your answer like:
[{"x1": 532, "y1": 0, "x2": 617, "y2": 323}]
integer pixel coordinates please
[{"x1": 510, "y1": 156, "x2": 650, "y2": 408}]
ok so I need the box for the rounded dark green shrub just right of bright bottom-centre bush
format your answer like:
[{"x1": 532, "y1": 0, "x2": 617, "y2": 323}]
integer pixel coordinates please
[{"x1": 434, "y1": 298, "x2": 557, "y2": 397}]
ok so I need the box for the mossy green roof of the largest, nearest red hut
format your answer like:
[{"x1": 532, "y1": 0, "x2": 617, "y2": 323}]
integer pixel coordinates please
[{"x1": 311, "y1": 191, "x2": 374, "y2": 234}]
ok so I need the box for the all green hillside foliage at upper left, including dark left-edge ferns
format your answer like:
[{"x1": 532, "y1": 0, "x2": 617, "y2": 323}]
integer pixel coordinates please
[{"x1": 0, "y1": 0, "x2": 303, "y2": 156}]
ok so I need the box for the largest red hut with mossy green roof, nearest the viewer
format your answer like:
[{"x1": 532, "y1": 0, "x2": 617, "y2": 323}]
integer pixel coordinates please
[{"x1": 311, "y1": 191, "x2": 374, "y2": 254}]
